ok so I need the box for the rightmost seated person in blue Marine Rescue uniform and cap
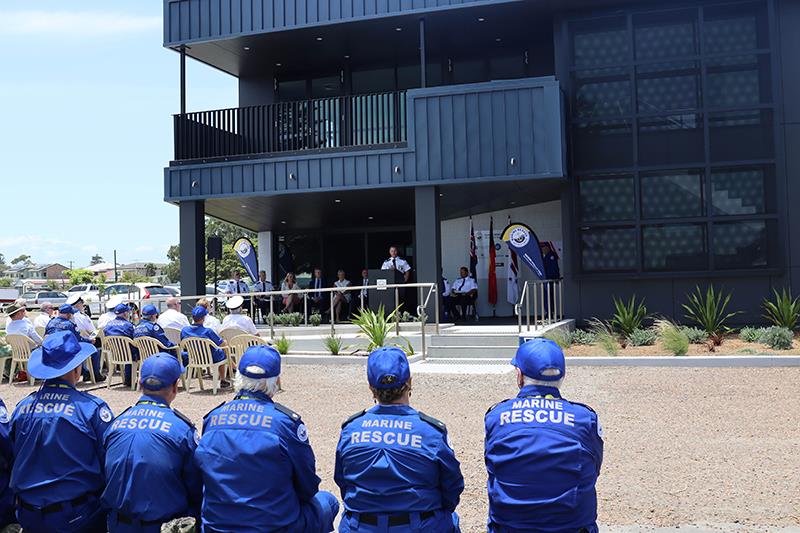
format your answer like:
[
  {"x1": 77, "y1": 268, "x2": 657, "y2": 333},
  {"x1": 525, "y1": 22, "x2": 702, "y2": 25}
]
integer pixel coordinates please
[{"x1": 484, "y1": 338, "x2": 603, "y2": 533}]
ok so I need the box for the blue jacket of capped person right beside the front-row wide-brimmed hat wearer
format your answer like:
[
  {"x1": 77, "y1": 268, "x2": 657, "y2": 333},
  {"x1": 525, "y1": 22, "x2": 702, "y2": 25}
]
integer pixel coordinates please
[{"x1": 103, "y1": 395, "x2": 203, "y2": 522}]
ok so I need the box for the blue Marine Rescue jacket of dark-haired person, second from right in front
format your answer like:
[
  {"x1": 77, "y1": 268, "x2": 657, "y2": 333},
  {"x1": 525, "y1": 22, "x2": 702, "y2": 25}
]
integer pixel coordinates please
[{"x1": 334, "y1": 405, "x2": 464, "y2": 512}]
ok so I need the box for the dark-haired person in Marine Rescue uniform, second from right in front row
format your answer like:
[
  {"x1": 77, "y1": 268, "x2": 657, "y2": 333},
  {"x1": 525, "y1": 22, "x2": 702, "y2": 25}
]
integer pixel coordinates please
[{"x1": 334, "y1": 348, "x2": 464, "y2": 533}]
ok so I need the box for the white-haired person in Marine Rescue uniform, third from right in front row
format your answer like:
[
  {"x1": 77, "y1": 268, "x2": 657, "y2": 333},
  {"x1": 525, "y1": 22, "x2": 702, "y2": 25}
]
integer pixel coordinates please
[{"x1": 195, "y1": 346, "x2": 339, "y2": 533}]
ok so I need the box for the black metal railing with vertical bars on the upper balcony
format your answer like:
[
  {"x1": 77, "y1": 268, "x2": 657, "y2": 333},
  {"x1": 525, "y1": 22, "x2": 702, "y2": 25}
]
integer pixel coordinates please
[{"x1": 174, "y1": 91, "x2": 406, "y2": 161}]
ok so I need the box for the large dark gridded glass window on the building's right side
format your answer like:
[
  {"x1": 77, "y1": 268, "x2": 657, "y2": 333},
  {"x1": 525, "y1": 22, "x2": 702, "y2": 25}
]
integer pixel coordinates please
[{"x1": 568, "y1": 0, "x2": 779, "y2": 273}]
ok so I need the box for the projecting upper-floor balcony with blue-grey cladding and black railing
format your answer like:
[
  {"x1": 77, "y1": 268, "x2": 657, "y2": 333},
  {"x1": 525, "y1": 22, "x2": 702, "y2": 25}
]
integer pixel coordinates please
[{"x1": 165, "y1": 77, "x2": 565, "y2": 202}]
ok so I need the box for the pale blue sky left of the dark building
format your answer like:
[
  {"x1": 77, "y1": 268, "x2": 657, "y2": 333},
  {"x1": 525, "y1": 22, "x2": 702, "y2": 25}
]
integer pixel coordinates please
[{"x1": 0, "y1": 0, "x2": 237, "y2": 267}]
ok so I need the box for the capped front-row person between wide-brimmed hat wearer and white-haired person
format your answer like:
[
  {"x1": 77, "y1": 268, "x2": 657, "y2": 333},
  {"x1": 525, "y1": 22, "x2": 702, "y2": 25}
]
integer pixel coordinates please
[{"x1": 103, "y1": 353, "x2": 203, "y2": 533}]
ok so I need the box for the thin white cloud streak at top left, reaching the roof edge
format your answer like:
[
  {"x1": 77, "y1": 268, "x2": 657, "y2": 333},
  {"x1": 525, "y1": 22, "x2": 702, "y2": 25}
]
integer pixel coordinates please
[{"x1": 0, "y1": 11, "x2": 162, "y2": 37}]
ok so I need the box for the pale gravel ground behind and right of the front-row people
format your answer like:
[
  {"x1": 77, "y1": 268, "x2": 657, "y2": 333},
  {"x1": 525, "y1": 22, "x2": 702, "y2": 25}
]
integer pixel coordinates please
[{"x1": 0, "y1": 366, "x2": 800, "y2": 533}]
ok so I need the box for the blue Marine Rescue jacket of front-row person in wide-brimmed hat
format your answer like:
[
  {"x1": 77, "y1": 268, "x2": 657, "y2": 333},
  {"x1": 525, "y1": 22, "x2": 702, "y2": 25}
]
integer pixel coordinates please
[{"x1": 11, "y1": 379, "x2": 114, "y2": 507}]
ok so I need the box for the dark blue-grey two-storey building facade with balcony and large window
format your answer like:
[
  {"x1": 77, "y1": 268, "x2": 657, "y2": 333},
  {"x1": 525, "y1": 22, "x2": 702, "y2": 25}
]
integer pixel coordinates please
[{"x1": 164, "y1": 0, "x2": 800, "y2": 321}]
